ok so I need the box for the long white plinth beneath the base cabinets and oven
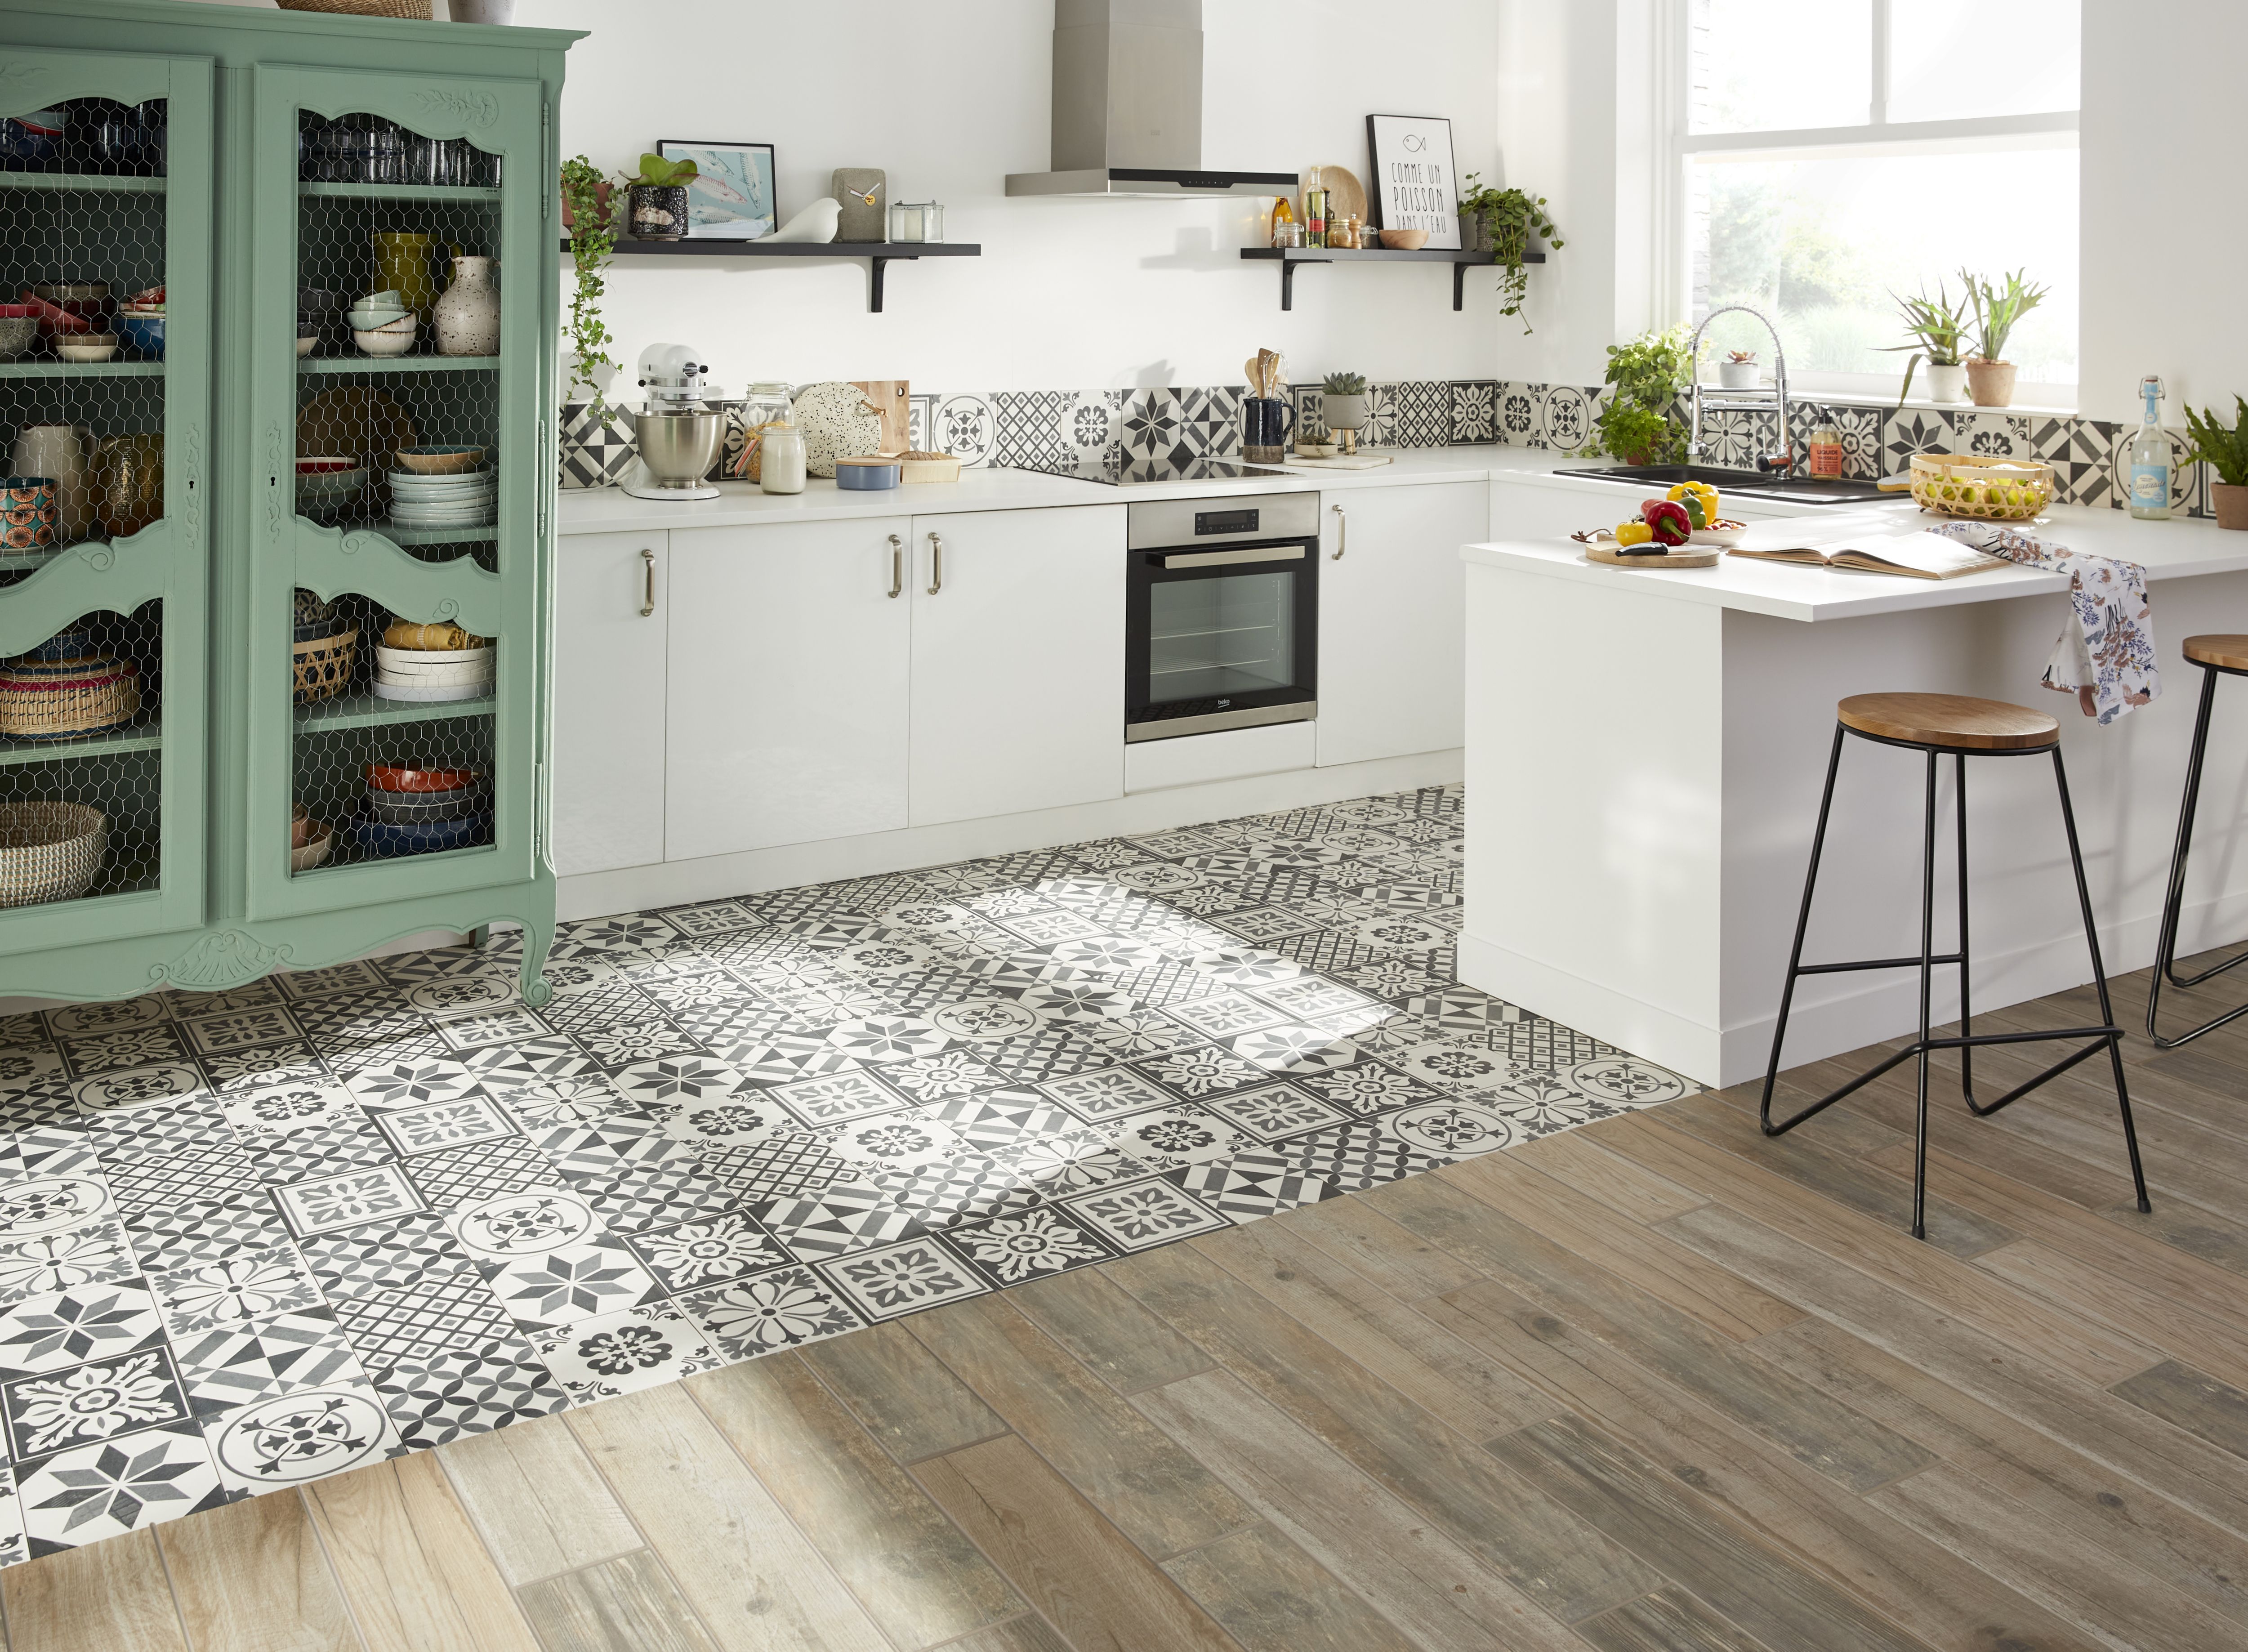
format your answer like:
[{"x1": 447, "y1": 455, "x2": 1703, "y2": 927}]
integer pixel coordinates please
[{"x1": 555, "y1": 746, "x2": 1461, "y2": 921}]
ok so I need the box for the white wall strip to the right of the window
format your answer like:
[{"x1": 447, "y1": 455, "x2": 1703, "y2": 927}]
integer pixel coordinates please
[{"x1": 2077, "y1": 0, "x2": 2248, "y2": 425}]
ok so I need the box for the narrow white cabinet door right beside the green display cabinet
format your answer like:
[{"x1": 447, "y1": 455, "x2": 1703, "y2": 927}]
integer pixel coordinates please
[{"x1": 549, "y1": 533, "x2": 670, "y2": 876}]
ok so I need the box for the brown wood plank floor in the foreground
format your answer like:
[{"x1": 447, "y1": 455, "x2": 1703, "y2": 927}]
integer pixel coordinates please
[{"x1": 0, "y1": 957, "x2": 2248, "y2": 1652}]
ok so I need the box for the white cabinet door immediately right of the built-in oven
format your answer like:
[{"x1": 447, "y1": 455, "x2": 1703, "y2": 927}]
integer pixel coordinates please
[{"x1": 1320, "y1": 481, "x2": 1490, "y2": 769}]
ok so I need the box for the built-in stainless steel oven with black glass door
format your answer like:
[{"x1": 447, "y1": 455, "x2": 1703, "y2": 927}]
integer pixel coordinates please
[{"x1": 1124, "y1": 492, "x2": 1320, "y2": 742}]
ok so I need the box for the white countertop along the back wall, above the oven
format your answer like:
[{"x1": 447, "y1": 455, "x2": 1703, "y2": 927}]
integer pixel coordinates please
[{"x1": 555, "y1": 447, "x2": 1553, "y2": 533}]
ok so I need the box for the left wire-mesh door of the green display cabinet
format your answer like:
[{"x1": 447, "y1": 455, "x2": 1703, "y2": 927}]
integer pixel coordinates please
[{"x1": 0, "y1": 49, "x2": 211, "y2": 953}]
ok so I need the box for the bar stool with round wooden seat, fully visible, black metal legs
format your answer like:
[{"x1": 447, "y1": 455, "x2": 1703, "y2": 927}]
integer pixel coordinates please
[{"x1": 1758, "y1": 688, "x2": 2149, "y2": 1238}]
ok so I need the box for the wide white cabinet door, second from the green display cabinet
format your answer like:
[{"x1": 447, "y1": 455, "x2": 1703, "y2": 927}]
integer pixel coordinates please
[{"x1": 650, "y1": 517, "x2": 913, "y2": 861}]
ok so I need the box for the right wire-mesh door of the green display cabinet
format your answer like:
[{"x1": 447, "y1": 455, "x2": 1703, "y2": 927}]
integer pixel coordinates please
[{"x1": 247, "y1": 67, "x2": 544, "y2": 917}]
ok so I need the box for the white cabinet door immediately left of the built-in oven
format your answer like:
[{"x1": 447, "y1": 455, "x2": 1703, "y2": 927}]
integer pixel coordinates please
[{"x1": 910, "y1": 506, "x2": 1133, "y2": 825}]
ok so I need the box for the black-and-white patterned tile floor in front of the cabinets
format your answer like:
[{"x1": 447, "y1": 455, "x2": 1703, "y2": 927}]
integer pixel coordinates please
[{"x1": 0, "y1": 787, "x2": 1688, "y2": 1562}]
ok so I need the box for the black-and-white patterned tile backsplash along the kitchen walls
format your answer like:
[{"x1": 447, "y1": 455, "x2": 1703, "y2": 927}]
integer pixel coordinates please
[{"x1": 895, "y1": 378, "x2": 2212, "y2": 517}]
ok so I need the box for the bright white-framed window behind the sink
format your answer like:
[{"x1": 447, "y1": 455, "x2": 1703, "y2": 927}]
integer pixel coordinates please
[{"x1": 1668, "y1": 0, "x2": 2079, "y2": 405}]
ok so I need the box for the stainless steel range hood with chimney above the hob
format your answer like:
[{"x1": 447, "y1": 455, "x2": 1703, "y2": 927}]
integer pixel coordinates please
[{"x1": 1007, "y1": 0, "x2": 1295, "y2": 198}]
